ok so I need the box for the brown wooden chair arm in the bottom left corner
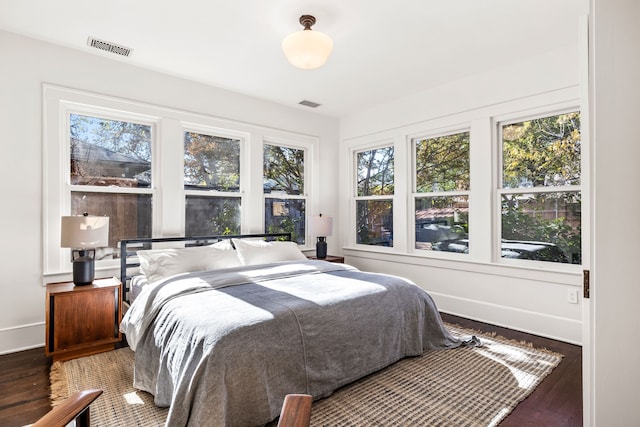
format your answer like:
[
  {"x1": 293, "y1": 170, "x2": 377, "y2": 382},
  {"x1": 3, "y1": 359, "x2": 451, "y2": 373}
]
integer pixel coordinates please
[{"x1": 32, "y1": 390, "x2": 102, "y2": 427}]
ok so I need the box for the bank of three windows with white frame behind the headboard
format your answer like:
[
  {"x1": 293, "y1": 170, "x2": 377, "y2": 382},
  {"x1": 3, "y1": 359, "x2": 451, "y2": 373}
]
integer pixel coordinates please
[{"x1": 43, "y1": 85, "x2": 319, "y2": 280}]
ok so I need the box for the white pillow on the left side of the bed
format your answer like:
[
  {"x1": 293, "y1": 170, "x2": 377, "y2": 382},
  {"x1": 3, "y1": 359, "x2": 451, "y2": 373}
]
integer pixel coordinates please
[{"x1": 138, "y1": 242, "x2": 242, "y2": 283}]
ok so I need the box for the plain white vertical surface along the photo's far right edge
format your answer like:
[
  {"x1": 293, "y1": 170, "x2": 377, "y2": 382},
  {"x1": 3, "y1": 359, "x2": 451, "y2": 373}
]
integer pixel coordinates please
[{"x1": 589, "y1": 0, "x2": 640, "y2": 426}]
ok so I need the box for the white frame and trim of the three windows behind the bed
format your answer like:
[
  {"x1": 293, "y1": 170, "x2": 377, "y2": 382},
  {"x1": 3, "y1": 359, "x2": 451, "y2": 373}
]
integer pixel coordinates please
[{"x1": 42, "y1": 83, "x2": 320, "y2": 282}]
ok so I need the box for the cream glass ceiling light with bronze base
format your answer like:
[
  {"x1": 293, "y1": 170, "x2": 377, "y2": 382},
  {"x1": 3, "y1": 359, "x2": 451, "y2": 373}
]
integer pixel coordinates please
[{"x1": 282, "y1": 15, "x2": 333, "y2": 70}]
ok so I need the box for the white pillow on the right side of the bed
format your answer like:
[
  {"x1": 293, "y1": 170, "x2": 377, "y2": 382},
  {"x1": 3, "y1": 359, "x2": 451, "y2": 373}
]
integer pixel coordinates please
[{"x1": 233, "y1": 239, "x2": 307, "y2": 265}]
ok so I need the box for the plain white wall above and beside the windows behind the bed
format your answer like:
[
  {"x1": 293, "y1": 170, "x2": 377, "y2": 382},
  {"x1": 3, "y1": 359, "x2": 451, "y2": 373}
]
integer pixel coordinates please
[{"x1": 0, "y1": 32, "x2": 340, "y2": 354}]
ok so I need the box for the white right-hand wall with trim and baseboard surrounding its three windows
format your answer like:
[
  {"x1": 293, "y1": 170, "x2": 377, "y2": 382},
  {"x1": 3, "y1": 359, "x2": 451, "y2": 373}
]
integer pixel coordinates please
[{"x1": 340, "y1": 45, "x2": 588, "y2": 343}]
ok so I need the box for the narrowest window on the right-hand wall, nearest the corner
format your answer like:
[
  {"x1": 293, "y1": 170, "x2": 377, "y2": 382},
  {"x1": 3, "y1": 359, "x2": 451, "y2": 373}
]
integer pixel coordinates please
[{"x1": 355, "y1": 146, "x2": 394, "y2": 247}]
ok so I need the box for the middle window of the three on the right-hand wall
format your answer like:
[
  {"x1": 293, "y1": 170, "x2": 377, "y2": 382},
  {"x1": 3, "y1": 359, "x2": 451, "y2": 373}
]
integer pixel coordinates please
[{"x1": 413, "y1": 132, "x2": 470, "y2": 253}]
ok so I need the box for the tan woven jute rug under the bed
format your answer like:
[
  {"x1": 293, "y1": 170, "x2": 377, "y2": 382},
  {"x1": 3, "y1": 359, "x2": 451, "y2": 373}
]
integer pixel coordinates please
[{"x1": 51, "y1": 325, "x2": 562, "y2": 427}]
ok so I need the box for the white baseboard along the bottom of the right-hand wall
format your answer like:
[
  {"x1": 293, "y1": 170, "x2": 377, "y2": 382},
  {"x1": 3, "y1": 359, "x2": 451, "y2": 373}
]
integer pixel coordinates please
[{"x1": 429, "y1": 292, "x2": 582, "y2": 345}]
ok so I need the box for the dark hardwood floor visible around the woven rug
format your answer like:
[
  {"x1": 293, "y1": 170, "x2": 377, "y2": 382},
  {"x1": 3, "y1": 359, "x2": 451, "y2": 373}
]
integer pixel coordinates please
[{"x1": 0, "y1": 314, "x2": 582, "y2": 427}]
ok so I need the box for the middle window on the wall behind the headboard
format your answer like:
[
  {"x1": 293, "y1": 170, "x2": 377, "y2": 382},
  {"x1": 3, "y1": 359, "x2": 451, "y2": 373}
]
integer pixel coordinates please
[{"x1": 184, "y1": 131, "x2": 241, "y2": 236}]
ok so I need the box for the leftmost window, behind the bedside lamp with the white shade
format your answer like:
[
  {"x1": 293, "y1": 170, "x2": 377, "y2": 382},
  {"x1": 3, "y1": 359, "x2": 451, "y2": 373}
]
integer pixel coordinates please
[{"x1": 68, "y1": 113, "x2": 152, "y2": 259}]
